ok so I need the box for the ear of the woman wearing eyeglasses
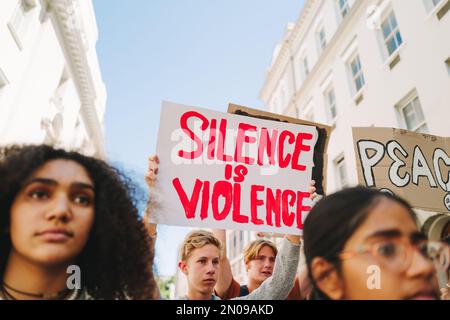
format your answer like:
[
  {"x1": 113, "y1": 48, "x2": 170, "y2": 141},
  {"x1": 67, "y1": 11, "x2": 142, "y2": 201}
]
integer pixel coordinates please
[{"x1": 311, "y1": 257, "x2": 344, "y2": 300}]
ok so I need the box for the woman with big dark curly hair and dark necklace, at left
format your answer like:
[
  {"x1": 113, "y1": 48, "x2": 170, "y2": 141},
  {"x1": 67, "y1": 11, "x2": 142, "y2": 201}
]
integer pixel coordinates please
[{"x1": 0, "y1": 146, "x2": 158, "y2": 299}]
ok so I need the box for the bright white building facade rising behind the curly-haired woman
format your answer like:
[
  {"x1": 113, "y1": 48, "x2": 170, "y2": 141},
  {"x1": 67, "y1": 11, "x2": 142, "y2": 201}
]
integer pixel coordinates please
[{"x1": 0, "y1": 0, "x2": 106, "y2": 158}]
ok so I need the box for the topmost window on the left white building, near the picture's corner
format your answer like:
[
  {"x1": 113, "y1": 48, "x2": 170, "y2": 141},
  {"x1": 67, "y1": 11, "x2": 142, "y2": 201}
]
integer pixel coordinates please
[{"x1": 8, "y1": 0, "x2": 36, "y2": 50}]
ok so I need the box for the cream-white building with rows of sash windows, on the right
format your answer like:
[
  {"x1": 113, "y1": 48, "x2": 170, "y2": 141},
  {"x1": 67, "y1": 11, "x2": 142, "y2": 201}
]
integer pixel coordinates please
[{"x1": 227, "y1": 0, "x2": 450, "y2": 283}]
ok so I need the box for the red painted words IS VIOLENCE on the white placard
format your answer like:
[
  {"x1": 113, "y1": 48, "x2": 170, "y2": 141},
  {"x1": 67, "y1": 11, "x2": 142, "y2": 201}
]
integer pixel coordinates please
[{"x1": 172, "y1": 165, "x2": 311, "y2": 230}]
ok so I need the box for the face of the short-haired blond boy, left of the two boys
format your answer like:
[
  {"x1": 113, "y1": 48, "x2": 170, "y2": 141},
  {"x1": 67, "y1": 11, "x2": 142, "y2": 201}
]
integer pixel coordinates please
[{"x1": 179, "y1": 244, "x2": 220, "y2": 294}]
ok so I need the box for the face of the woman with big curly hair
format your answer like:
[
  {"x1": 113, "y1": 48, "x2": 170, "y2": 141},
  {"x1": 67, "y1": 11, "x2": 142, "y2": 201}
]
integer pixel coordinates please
[{"x1": 10, "y1": 159, "x2": 95, "y2": 266}]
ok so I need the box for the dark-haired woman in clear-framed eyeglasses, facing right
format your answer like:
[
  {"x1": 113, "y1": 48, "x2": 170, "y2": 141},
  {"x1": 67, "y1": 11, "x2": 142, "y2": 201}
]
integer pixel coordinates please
[{"x1": 303, "y1": 187, "x2": 448, "y2": 300}]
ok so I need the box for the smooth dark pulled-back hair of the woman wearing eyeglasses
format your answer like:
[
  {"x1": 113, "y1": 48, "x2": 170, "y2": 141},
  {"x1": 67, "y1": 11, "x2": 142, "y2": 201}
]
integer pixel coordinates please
[{"x1": 303, "y1": 187, "x2": 417, "y2": 299}]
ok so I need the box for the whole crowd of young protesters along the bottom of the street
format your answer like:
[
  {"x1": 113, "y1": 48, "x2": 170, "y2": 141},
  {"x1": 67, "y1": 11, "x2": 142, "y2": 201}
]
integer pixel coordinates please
[{"x1": 0, "y1": 145, "x2": 450, "y2": 300}]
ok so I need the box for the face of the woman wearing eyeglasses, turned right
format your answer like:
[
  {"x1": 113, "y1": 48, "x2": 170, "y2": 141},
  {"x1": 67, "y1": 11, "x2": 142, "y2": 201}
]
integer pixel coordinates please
[{"x1": 341, "y1": 198, "x2": 439, "y2": 300}]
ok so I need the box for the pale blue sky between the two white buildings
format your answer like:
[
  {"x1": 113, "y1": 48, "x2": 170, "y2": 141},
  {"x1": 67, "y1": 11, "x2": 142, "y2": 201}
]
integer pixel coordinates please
[{"x1": 93, "y1": 0, "x2": 304, "y2": 276}]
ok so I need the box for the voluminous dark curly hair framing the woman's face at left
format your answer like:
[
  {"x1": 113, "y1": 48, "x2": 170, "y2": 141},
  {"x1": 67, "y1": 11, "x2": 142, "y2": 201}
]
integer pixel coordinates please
[{"x1": 0, "y1": 145, "x2": 157, "y2": 299}]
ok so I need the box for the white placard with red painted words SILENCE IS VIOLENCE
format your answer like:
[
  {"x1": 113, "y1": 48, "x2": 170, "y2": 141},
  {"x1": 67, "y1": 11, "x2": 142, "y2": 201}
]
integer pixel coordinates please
[{"x1": 152, "y1": 102, "x2": 330, "y2": 234}]
